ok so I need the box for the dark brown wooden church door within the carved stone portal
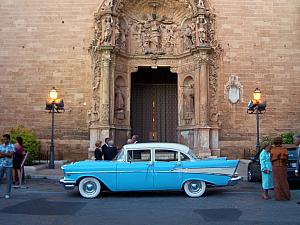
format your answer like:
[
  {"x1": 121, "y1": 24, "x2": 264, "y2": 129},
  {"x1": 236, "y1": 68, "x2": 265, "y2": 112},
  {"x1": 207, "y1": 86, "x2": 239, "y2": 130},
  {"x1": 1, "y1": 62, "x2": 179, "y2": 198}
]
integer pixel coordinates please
[{"x1": 131, "y1": 84, "x2": 178, "y2": 142}]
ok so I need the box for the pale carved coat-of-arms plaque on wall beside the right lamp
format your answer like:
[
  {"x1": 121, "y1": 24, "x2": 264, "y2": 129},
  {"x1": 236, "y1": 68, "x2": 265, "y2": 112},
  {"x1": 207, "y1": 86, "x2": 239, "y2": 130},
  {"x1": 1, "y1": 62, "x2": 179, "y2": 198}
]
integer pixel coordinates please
[{"x1": 224, "y1": 75, "x2": 243, "y2": 104}]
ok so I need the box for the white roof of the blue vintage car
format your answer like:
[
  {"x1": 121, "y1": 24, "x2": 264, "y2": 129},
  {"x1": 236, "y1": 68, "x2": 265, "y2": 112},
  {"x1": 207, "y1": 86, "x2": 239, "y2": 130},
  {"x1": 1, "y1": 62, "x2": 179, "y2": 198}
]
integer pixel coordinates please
[{"x1": 123, "y1": 142, "x2": 190, "y2": 154}]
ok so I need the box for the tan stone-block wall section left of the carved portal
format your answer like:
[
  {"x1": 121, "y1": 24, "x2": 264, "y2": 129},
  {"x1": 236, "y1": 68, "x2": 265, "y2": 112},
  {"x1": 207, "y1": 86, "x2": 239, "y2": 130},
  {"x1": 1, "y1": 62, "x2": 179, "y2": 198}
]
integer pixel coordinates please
[{"x1": 0, "y1": 0, "x2": 99, "y2": 158}]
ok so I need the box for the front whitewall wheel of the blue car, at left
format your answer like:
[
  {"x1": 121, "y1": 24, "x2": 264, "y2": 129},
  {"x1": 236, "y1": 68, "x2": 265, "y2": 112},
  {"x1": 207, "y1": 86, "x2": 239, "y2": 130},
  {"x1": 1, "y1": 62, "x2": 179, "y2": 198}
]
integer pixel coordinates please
[{"x1": 78, "y1": 177, "x2": 101, "y2": 198}]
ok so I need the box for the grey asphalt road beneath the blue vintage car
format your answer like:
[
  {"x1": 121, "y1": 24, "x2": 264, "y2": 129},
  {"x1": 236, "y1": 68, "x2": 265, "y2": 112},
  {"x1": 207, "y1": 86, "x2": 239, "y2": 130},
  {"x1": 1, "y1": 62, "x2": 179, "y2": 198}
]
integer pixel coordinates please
[{"x1": 0, "y1": 179, "x2": 300, "y2": 225}]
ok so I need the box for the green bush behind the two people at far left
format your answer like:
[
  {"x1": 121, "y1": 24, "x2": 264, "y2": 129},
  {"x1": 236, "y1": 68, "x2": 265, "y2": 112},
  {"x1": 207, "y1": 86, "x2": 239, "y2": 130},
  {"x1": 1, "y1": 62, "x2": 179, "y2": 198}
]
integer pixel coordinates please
[{"x1": 9, "y1": 126, "x2": 40, "y2": 165}]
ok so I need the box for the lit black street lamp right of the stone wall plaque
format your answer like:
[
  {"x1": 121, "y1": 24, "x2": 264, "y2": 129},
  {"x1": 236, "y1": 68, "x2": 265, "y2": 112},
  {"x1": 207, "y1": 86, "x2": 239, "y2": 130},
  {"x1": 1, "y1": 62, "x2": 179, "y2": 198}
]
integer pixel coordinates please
[{"x1": 247, "y1": 88, "x2": 267, "y2": 152}]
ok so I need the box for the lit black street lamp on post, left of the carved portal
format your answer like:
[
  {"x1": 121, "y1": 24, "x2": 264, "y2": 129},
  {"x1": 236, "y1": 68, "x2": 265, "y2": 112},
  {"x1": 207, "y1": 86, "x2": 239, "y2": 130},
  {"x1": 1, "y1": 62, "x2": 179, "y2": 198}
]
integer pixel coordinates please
[{"x1": 46, "y1": 87, "x2": 65, "y2": 169}]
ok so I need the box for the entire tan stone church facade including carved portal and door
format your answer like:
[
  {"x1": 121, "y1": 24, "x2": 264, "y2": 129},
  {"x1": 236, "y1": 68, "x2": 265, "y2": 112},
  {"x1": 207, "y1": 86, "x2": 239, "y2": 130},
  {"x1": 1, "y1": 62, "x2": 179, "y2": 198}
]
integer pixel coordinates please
[{"x1": 0, "y1": 0, "x2": 300, "y2": 160}]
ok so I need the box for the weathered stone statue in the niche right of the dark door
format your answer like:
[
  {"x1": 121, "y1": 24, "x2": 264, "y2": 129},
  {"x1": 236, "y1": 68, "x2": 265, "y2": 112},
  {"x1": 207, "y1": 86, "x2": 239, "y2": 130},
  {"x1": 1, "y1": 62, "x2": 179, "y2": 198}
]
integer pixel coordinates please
[{"x1": 183, "y1": 84, "x2": 195, "y2": 119}]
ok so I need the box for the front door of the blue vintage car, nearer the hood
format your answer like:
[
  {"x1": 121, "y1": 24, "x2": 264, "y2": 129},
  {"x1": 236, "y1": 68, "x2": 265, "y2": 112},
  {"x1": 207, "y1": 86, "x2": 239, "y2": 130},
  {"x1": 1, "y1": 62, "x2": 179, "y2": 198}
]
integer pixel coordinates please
[{"x1": 117, "y1": 149, "x2": 153, "y2": 191}]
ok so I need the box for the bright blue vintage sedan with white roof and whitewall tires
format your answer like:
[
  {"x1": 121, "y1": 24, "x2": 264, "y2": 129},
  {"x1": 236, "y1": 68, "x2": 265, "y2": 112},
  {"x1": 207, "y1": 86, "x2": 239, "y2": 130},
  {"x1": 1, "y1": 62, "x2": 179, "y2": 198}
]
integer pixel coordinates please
[{"x1": 60, "y1": 143, "x2": 240, "y2": 198}]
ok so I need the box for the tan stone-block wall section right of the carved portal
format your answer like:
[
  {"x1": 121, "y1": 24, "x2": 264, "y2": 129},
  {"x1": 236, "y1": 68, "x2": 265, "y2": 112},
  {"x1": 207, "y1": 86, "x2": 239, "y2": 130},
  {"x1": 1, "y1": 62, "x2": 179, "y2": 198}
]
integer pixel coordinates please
[{"x1": 211, "y1": 0, "x2": 300, "y2": 156}]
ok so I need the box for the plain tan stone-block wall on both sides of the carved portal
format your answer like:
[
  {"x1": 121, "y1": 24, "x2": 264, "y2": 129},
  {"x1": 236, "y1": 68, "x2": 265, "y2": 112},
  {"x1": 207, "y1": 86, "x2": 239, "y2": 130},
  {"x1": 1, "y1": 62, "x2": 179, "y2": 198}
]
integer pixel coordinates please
[{"x1": 0, "y1": 0, "x2": 300, "y2": 160}]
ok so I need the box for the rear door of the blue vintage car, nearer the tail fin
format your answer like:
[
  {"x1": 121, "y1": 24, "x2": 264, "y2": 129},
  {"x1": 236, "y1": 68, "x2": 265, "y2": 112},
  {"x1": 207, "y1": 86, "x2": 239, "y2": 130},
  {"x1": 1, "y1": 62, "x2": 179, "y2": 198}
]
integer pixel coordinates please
[{"x1": 153, "y1": 149, "x2": 182, "y2": 190}]
